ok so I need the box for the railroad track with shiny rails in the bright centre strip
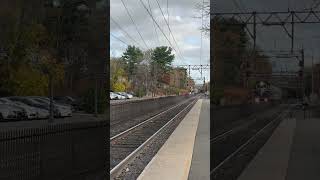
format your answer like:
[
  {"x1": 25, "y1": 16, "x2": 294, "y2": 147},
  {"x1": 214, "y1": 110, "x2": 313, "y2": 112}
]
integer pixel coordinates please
[{"x1": 110, "y1": 97, "x2": 198, "y2": 179}]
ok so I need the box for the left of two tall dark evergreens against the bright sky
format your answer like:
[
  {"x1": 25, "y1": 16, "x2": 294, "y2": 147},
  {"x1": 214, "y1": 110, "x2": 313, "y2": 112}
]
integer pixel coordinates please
[{"x1": 122, "y1": 46, "x2": 143, "y2": 79}]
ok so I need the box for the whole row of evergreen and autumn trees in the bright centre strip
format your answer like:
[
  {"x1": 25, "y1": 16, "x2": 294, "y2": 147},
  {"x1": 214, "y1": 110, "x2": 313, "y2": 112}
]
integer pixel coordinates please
[{"x1": 110, "y1": 45, "x2": 187, "y2": 96}]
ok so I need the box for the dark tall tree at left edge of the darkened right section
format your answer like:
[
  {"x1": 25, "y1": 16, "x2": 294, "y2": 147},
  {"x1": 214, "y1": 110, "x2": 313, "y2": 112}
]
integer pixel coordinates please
[{"x1": 211, "y1": 19, "x2": 249, "y2": 87}]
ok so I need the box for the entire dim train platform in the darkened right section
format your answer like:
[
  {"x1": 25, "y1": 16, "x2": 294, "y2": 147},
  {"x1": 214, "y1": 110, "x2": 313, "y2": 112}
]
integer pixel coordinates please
[{"x1": 238, "y1": 112, "x2": 320, "y2": 180}]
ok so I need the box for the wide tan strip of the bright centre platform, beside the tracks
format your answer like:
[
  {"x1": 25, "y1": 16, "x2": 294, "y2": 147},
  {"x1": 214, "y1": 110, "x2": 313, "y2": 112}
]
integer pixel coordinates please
[{"x1": 138, "y1": 99, "x2": 203, "y2": 180}]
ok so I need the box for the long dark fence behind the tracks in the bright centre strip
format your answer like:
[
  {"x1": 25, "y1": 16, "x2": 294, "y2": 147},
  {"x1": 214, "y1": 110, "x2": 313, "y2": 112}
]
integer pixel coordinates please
[{"x1": 110, "y1": 95, "x2": 190, "y2": 121}]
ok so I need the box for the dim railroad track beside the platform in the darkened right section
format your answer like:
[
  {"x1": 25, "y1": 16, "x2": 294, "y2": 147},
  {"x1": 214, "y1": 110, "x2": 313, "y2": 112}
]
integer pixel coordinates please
[{"x1": 210, "y1": 105, "x2": 290, "y2": 177}]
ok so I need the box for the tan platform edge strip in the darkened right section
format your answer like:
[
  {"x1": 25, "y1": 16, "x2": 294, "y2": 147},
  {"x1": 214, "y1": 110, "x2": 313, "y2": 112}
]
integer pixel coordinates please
[{"x1": 238, "y1": 118, "x2": 296, "y2": 180}]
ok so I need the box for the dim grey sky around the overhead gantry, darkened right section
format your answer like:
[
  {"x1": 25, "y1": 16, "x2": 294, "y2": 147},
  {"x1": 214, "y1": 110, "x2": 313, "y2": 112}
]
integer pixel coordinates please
[{"x1": 215, "y1": 0, "x2": 320, "y2": 70}]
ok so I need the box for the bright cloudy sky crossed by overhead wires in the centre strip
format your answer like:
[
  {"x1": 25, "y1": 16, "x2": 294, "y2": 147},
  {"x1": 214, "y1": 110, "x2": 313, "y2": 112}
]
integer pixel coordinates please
[{"x1": 110, "y1": 0, "x2": 210, "y2": 83}]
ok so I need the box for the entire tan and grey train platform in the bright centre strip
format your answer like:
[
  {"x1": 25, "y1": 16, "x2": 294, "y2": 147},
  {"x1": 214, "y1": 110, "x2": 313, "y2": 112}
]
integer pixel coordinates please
[{"x1": 138, "y1": 99, "x2": 210, "y2": 180}]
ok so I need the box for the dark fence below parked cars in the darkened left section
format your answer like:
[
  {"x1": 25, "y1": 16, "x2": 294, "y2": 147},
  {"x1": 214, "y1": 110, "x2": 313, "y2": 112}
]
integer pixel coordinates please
[{"x1": 0, "y1": 120, "x2": 109, "y2": 180}]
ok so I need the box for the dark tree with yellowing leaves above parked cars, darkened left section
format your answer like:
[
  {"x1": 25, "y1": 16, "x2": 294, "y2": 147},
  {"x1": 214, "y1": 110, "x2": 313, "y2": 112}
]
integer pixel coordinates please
[{"x1": 0, "y1": 7, "x2": 64, "y2": 95}]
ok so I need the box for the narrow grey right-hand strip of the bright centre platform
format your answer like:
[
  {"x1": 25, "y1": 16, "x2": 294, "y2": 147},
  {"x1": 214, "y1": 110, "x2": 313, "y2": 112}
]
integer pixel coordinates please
[{"x1": 188, "y1": 99, "x2": 210, "y2": 180}]
